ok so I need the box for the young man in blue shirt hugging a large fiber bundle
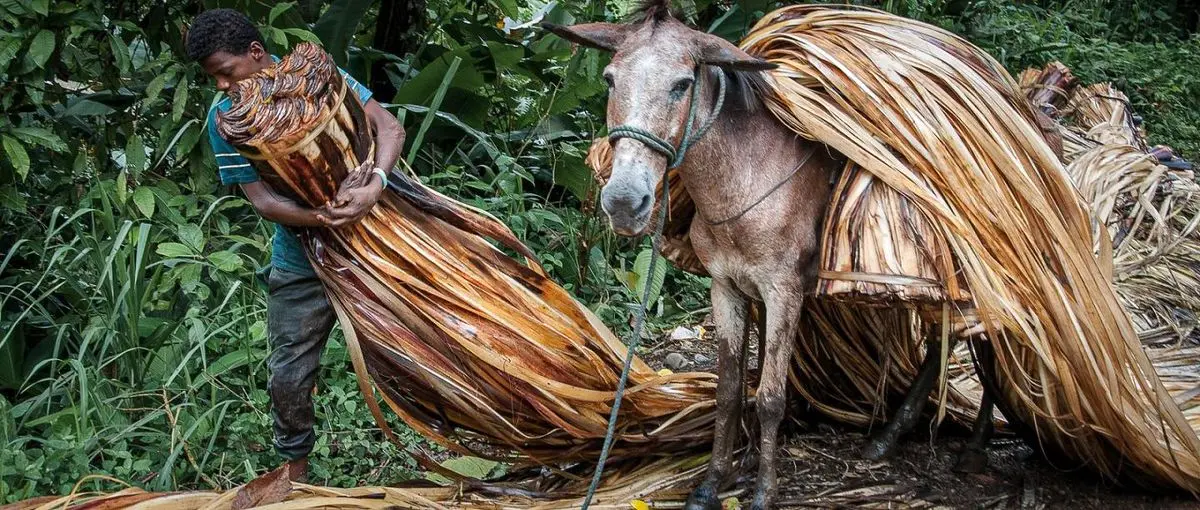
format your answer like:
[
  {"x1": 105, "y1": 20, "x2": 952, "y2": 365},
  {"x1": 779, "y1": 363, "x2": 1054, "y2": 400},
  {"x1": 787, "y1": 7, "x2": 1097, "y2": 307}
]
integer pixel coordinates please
[{"x1": 187, "y1": 8, "x2": 404, "y2": 481}]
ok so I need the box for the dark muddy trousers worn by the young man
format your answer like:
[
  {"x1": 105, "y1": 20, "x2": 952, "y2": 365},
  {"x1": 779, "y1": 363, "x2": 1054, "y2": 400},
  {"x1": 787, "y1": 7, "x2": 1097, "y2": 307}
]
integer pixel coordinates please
[{"x1": 266, "y1": 268, "x2": 335, "y2": 460}]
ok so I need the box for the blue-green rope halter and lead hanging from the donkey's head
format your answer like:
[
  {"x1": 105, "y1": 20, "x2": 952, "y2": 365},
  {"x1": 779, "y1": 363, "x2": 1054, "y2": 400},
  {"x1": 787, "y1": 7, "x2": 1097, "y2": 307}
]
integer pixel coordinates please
[{"x1": 583, "y1": 66, "x2": 725, "y2": 510}]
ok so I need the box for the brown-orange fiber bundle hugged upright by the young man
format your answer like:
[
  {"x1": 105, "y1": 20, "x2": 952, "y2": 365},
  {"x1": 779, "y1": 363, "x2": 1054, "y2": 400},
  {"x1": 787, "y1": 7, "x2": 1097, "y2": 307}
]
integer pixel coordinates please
[{"x1": 218, "y1": 44, "x2": 715, "y2": 464}]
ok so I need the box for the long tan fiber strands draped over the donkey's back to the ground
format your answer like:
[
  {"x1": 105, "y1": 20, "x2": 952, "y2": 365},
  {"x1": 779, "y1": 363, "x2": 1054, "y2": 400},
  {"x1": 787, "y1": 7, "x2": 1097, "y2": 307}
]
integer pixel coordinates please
[{"x1": 742, "y1": 6, "x2": 1200, "y2": 491}]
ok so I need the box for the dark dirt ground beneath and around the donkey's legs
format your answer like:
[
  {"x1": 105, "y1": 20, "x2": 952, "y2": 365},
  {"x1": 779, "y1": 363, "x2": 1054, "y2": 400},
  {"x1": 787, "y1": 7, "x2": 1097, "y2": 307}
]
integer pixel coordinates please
[{"x1": 642, "y1": 324, "x2": 1200, "y2": 510}]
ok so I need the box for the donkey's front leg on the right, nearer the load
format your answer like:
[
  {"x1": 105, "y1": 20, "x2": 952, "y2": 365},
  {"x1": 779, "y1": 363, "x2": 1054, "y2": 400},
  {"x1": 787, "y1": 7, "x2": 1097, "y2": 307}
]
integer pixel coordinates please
[{"x1": 750, "y1": 284, "x2": 804, "y2": 510}]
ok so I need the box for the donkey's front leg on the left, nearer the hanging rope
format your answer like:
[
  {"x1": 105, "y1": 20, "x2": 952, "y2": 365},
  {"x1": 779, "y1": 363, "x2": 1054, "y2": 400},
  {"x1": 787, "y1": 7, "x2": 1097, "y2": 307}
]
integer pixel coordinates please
[{"x1": 686, "y1": 277, "x2": 746, "y2": 510}]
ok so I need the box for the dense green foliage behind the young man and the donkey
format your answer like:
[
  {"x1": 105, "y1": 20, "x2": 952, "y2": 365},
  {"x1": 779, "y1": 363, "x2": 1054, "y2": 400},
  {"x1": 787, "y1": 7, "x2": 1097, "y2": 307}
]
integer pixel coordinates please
[{"x1": 0, "y1": 0, "x2": 1200, "y2": 503}]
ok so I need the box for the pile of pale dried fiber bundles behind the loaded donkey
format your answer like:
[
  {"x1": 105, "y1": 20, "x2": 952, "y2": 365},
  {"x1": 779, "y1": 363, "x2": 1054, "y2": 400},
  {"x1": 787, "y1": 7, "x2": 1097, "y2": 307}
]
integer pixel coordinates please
[{"x1": 1022, "y1": 62, "x2": 1200, "y2": 343}]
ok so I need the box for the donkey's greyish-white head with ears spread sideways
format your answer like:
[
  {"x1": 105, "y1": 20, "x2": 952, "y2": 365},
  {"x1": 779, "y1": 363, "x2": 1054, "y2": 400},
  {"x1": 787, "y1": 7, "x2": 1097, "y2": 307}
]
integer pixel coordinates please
[{"x1": 545, "y1": 0, "x2": 774, "y2": 235}]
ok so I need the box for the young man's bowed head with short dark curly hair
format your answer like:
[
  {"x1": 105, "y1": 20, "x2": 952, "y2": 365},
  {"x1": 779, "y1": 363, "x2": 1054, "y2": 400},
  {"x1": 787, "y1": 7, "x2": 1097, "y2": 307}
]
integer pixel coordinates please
[{"x1": 187, "y1": 8, "x2": 271, "y2": 91}]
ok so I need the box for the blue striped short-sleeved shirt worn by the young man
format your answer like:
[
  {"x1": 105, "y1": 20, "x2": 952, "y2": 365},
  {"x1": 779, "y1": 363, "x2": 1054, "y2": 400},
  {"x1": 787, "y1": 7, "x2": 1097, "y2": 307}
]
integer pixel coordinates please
[{"x1": 208, "y1": 55, "x2": 371, "y2": 276}]
